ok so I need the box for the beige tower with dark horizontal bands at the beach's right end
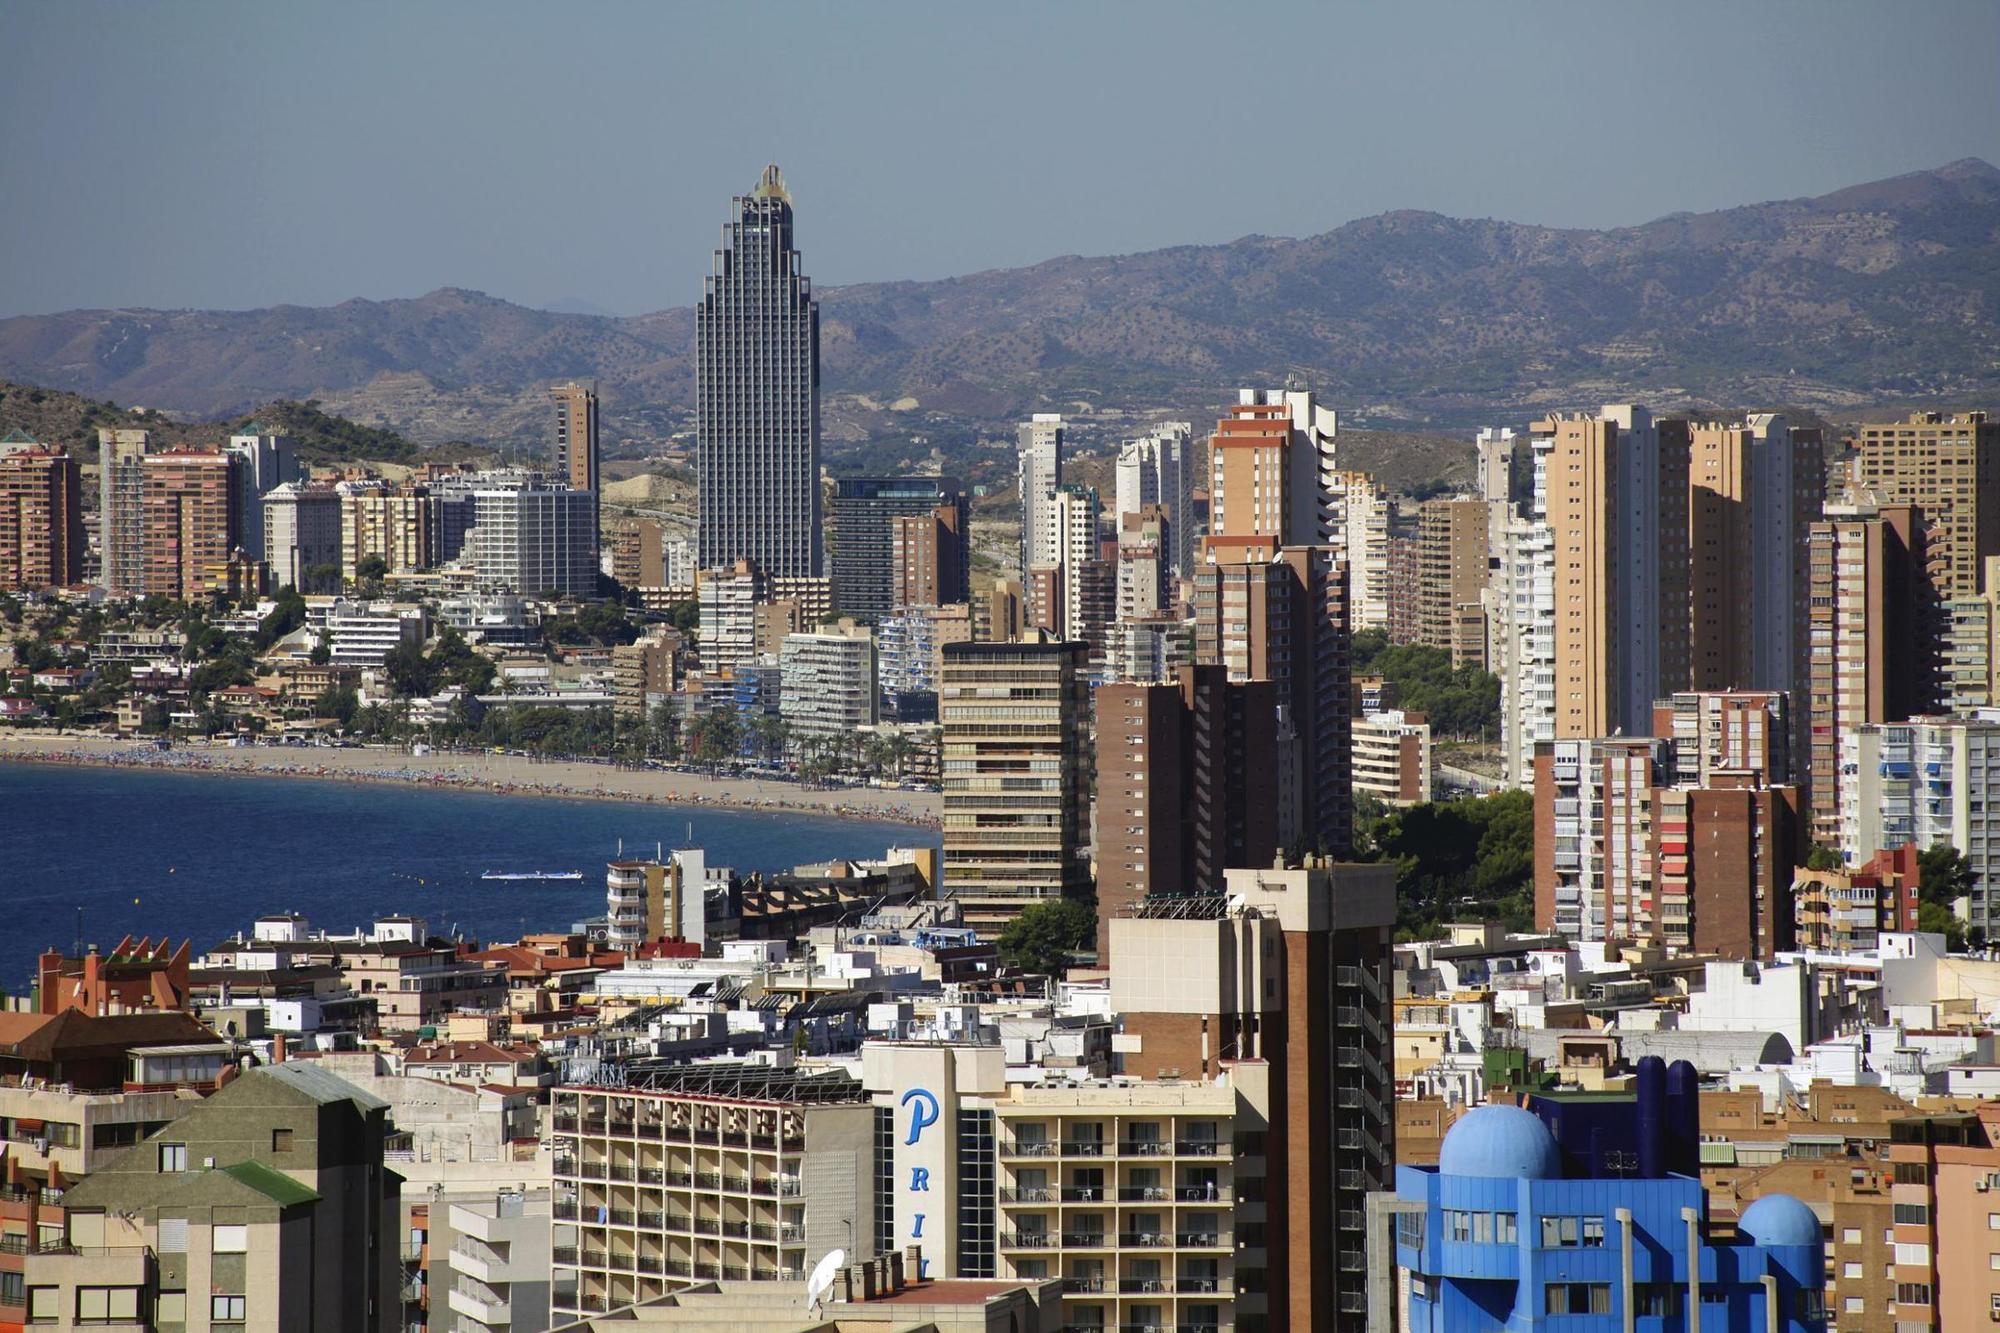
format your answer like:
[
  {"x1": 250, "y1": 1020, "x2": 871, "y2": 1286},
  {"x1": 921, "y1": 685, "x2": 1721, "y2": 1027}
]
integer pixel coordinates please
[{"x1": 938, "y1": 640, "x2": 1090, "y2": 939}]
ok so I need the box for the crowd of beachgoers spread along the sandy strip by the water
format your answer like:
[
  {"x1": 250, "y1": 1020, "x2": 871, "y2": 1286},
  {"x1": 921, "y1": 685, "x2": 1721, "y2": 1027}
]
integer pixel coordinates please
[{"x1": 0, "y1": 747, "x2": 942, "y2": 829}]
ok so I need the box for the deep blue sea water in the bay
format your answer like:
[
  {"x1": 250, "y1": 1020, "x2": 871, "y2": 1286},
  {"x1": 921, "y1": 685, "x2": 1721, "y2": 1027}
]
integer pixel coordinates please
[{"x1": 0, "y1": 763, "x2": 938, "y2": 995}]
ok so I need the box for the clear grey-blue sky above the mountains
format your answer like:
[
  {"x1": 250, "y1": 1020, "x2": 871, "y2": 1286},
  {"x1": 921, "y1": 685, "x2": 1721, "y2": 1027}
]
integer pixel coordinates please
[{"x1": 0, "y1": 0, "x2": 2000, "y2": 316}]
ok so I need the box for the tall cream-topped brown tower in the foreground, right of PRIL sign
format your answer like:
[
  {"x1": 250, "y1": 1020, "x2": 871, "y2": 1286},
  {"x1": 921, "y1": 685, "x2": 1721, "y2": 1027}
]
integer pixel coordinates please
[{"x1": 1110, "y1": 863, "x2": 1396, "y2": 1333}]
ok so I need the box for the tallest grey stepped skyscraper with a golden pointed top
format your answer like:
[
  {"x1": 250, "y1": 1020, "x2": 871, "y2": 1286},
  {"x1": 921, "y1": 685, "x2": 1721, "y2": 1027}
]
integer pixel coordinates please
[{"x1": 694, "y1": 166, "x2": 822, "y2": 578}]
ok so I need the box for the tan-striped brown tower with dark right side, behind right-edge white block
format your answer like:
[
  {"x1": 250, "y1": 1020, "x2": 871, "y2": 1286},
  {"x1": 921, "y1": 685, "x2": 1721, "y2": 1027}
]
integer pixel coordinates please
[{"x1": 1806, "y1": 504, "x2": 1936, "y2": 847}]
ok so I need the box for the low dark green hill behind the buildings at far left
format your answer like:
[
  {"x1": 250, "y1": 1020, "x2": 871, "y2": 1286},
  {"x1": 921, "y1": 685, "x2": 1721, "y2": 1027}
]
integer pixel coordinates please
[{"x1": 0, "y1": 380, "x2": 492, "y2": 464}]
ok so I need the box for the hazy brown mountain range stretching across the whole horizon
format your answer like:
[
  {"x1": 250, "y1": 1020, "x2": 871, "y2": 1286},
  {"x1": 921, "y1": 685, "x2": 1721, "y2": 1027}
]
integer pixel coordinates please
[{"x1": 0, "y1": 158, "x2": 2000, "y2": 448}]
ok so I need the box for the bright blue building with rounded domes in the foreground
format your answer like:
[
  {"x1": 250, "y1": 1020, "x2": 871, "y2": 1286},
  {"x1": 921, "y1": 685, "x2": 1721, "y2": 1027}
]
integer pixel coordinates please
[{"x1": 1396, "y1": 1057, "x2": 1826, "y2": 1333}]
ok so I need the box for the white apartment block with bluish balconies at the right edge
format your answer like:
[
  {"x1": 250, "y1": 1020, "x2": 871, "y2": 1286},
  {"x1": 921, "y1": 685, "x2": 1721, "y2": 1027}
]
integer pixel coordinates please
[{"x1": 1840, "y1": 711, "x2": 2000, "y2": 933}]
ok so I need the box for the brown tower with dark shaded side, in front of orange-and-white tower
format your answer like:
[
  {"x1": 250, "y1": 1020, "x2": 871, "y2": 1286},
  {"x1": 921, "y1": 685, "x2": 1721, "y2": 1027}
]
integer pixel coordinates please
[{"x1": 1194, "y1": 546, "x2": 1354, "y2": 855}]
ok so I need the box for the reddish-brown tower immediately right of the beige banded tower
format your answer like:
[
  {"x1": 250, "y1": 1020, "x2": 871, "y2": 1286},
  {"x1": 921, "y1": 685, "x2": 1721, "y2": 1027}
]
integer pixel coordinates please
[{"x1": 1096, "y1": 667, "x2": 1278, "y2": 957}]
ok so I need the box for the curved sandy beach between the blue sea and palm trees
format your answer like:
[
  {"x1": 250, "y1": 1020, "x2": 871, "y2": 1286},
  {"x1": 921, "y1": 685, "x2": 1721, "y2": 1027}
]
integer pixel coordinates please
[{"x1": 0, "y1": 733, "x2": 942, "y2": 829}]
